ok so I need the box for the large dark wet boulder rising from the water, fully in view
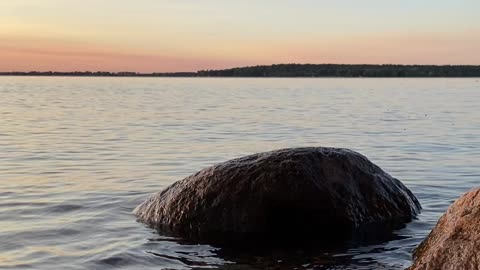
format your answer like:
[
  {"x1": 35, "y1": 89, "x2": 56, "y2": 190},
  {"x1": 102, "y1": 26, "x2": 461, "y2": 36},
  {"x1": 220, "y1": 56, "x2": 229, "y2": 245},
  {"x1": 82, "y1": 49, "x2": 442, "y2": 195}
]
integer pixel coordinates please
[{"x1": 134, "y1": 147, "x2": 420, "y2": 244}]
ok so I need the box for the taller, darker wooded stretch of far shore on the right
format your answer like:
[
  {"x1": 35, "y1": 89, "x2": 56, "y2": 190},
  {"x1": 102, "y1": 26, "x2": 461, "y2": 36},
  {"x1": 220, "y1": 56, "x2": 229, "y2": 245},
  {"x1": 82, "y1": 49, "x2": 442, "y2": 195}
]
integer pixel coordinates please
[{"x1": 197, "y1": 64, "x2": 480, "y2": 77}]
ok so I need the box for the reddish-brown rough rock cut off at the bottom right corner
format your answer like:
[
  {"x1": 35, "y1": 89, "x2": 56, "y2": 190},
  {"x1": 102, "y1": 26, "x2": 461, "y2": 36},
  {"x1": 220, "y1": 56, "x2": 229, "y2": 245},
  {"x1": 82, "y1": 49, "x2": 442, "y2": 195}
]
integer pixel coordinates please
[{"x1": 409, "y1": 188, "x2": 480, "y2": 270}]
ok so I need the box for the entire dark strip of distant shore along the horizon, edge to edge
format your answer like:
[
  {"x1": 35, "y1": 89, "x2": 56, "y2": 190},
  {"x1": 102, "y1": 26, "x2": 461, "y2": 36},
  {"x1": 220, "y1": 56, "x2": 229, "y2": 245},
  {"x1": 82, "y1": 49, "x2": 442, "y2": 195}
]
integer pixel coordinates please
[{"x1": 0, "y1": 64, "x2": 480, "y2": 78}]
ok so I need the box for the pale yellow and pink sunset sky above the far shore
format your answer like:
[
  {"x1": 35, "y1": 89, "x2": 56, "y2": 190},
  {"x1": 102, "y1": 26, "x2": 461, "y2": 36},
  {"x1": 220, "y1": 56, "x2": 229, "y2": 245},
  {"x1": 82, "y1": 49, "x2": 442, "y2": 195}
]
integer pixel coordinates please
[{"x1": 0, "y1": 0, "x2": 480, "y2": 72}]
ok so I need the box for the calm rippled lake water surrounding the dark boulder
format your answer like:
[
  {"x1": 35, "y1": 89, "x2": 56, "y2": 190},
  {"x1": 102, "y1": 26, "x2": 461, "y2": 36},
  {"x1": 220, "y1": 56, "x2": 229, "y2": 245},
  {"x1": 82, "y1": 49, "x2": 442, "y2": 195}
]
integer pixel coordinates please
[{"x1": 0, "y1": 77, "x2": 480, "y2": 269}]
